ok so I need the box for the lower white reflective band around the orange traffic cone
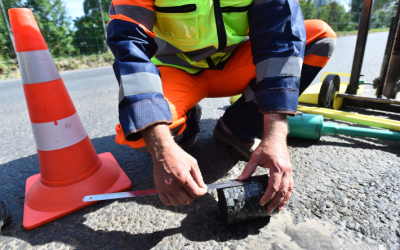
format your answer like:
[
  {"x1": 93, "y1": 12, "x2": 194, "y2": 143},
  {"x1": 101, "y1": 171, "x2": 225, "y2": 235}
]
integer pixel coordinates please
[{"x1": 32, "y1": 113, "x2": 87, "y2": 151}]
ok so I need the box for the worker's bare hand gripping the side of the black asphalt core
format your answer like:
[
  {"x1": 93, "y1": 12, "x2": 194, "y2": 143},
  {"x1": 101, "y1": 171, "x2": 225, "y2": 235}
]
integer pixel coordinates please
[{"x1": 239, "y1": 114, "x2": 294, "y2": 213}]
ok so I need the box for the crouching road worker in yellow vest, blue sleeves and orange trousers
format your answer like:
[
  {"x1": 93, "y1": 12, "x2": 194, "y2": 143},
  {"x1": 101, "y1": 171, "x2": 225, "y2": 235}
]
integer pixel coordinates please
[{"x1": 107, "y1": 0, "x2": 336, "y2": 212}]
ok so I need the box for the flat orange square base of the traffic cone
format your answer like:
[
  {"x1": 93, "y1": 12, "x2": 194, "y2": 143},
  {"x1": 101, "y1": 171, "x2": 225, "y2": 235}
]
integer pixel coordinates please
[{"x1": 23, "y1": 152, "x2": 132, "y2": 230}]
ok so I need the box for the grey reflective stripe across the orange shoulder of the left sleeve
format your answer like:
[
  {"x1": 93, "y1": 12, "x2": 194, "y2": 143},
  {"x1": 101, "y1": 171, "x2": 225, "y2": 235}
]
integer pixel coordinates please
[{"x1": 112, "y1": 4, "x2": 156, "y2": 30}]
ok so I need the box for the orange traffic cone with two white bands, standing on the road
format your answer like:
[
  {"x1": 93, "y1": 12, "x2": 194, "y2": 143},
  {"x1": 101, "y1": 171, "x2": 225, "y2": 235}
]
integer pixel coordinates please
[{"x1": 8, "y1": 8, "x2": 131, "y2": 230}]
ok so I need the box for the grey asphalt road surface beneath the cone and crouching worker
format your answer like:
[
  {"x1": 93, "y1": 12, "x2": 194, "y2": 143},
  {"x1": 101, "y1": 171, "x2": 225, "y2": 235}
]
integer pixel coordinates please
[{"x1": 0, "y1": 33, "x2": 400, "y2": 249}]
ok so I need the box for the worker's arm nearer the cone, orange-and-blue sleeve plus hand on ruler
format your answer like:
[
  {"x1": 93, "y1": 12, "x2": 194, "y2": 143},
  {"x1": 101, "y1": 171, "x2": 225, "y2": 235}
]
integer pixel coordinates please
[{"x1": 107, "y1": 0, "x2": 206, "y2": 205}]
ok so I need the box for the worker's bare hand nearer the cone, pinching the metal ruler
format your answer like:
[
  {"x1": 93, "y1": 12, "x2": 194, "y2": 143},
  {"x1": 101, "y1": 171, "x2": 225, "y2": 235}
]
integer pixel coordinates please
[{"x1": 142, "y1": 122, "x2": 207, "y2": 206}]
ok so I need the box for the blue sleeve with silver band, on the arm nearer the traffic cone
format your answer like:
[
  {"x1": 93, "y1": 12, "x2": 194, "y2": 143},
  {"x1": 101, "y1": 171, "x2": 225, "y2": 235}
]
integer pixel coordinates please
[{"x1": 107, "y1": 19, "x2": 172, "y2": 141}]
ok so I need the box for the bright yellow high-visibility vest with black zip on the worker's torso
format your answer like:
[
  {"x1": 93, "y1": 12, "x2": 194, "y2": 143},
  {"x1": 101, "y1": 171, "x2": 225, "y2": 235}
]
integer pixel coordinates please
[{"x1": 151, "y1": 0, "x2": 253, "y2": 74}]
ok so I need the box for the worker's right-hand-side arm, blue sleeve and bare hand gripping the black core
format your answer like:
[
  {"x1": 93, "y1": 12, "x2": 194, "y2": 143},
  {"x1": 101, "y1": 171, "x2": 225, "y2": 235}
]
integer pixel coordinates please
[{"x1": 240, "y1": 0, "x2": 306, "y2": 212}]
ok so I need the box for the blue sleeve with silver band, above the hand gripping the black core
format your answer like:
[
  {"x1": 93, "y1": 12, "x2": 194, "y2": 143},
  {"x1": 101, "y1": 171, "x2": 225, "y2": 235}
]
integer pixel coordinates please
[{"x1": 249, "y1": 0, "x2": 306, "y2": 115}]
